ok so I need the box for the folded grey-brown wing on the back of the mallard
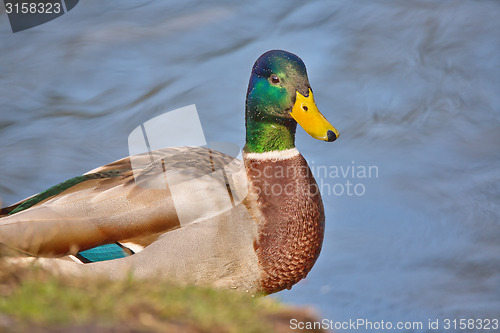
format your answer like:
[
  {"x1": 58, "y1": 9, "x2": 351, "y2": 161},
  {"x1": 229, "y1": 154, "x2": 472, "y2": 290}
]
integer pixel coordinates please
[{"x1": 0, "y1": 147, "x2": 242, "y2": 256}]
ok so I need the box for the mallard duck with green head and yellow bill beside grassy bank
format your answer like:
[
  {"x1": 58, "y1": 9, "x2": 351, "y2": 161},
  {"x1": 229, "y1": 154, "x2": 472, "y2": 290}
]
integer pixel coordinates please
[{"x1": 0, "y1": 50, "x2": 339, "y2": 294}]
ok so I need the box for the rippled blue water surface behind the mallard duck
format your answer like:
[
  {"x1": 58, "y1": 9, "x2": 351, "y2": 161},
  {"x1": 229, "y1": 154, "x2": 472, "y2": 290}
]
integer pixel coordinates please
[{"x1": 0, "y1": 0, "x2": 500, "y2": 332}]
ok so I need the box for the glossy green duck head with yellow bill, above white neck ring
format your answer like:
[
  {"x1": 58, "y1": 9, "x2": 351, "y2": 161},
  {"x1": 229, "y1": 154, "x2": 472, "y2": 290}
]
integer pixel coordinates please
[{"x1": 245, "y1": 50, "x2": 338, "y2": 153}]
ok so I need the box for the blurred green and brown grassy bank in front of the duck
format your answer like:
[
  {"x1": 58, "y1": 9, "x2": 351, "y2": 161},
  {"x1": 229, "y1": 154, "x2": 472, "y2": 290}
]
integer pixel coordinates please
[{"x1": 0, "y1": 253, "x2": 326, "y2": 333}]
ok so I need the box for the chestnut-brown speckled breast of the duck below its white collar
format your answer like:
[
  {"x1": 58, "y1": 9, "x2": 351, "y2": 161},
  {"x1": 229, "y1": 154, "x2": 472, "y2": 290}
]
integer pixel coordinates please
[{"x1": 245, "y1": 154, "x2": 325, "y2": 293}]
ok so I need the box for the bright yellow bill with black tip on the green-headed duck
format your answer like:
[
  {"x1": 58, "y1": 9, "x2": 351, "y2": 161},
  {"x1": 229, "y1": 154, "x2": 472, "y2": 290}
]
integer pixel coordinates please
[{"x1": 290, "y1": 89, "x2": 339, "y2": 141}]
